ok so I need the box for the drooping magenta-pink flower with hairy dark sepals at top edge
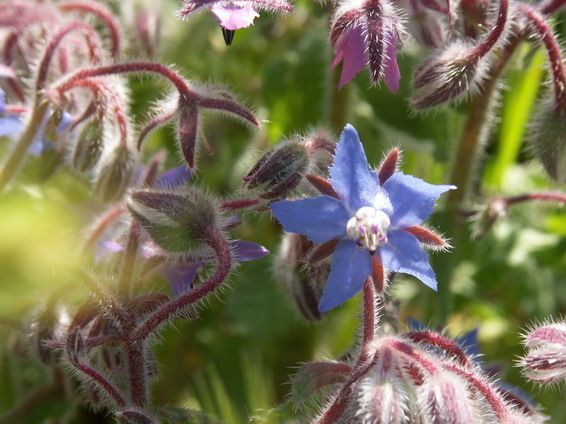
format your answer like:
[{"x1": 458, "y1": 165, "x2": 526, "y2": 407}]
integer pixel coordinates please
[{"x1": 330, "y1": 0, "x2": 403, "y2": 92}]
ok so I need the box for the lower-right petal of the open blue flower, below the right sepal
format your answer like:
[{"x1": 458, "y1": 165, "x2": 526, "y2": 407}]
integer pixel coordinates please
[{"x1": 379, "y1": 231, "x2": 437, "y2": 290}]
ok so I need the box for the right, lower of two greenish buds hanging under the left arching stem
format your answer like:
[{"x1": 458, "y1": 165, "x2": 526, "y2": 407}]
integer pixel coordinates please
[{"x1": 94, "y1": 146, "x2": 134, "y2": 202}]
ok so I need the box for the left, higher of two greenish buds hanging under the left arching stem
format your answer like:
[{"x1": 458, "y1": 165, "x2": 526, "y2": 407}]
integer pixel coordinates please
[{"x1": 73, "y1": 119, "x2": 104, "y2": 172}]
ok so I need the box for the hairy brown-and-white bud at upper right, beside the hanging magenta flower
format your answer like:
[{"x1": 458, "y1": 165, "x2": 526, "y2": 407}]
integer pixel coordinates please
[{"x1": 411, "y1": 43, "x2": 487, "y2": 109}]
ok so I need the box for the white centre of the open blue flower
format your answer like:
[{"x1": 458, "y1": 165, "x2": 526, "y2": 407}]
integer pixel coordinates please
[{"x1": 346, "y1": 206, "x2": 391, "y2": 255}]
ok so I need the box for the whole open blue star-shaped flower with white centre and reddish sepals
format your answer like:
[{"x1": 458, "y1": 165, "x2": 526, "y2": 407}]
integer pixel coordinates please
[{"x1": 272, "y1": 125, "x2": 455, "y2": 312}]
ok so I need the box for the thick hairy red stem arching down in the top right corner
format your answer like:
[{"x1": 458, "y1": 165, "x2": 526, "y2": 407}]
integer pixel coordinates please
[{"x1": 518, "y1": 3, "x2": 566, "y2": 111}]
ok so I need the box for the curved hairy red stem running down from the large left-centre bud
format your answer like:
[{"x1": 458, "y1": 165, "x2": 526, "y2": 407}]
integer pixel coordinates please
[{"x1": 131, "y1": 233, "x2": 232, "y2": 340}]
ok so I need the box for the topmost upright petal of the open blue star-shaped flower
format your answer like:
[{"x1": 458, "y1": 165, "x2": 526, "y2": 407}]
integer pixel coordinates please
[{"x1": 330, "y1": 124, "x2": 379, "y2": 213}]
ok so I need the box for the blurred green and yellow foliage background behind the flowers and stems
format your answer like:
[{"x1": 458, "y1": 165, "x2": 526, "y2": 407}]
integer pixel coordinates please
[{"x1": 0, "y1": 0, "x2": 566, "y2": 423}]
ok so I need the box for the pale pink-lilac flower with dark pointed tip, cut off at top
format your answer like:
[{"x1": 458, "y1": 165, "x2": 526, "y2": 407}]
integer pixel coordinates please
[{"x1": 179, "y1": 0, "x2": 293, "y2": 45}]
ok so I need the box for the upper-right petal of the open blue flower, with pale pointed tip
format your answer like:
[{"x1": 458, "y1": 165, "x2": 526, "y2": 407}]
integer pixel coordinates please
[{"x1": 383, "y1": 172, "x2": 456, "y2": 228}]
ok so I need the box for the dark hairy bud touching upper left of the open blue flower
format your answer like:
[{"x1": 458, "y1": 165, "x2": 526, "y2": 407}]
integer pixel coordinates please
[{"x1": 244, "y1": 140, "x2": 309, "y2": 200}]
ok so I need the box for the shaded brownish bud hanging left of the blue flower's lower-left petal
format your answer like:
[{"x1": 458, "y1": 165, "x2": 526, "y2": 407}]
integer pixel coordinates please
[{"x1": 275, "y1": 233, "x2": 330, "y2": 321}]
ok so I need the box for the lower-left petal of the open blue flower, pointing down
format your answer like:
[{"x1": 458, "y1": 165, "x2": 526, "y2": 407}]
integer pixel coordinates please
[{"x1": 318, "y1": 240, "x2": 371, "y2": 312}]
